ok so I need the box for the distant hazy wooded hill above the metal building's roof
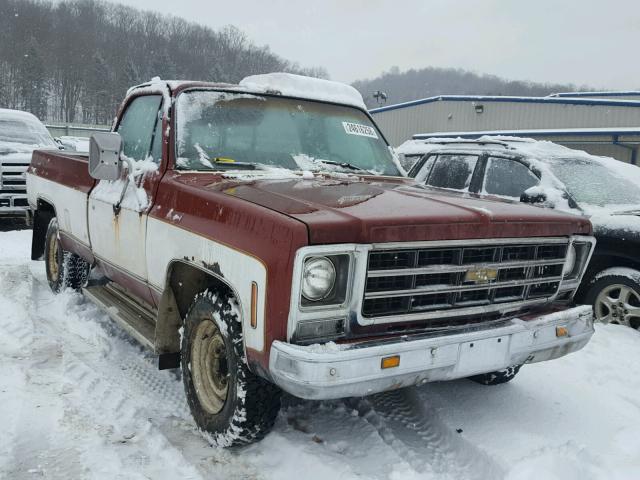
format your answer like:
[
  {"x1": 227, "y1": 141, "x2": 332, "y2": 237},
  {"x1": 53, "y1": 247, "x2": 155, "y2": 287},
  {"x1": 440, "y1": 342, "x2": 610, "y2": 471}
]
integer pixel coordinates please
[{"x1": 353, "y1": 67, "x2": 589, "y2": 107}]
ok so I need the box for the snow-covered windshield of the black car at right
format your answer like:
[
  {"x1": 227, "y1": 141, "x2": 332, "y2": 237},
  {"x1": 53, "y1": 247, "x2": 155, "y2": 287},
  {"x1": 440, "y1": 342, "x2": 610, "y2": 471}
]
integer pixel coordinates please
[{"x1": 548, "y1": 158, "x2": 640, "y2": 206}]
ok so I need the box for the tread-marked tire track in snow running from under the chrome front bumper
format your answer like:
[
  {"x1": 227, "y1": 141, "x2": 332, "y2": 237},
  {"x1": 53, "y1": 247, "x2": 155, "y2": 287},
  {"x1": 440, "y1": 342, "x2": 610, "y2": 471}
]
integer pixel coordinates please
[{"x1": 348, "y1": 387, "x2": 505, "y2": 480}]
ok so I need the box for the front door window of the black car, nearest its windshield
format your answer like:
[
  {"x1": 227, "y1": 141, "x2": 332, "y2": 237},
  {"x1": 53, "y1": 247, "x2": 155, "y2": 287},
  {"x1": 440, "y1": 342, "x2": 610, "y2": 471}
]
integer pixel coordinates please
[{"x1": 483, "y1": 157, "x2": 540, "y2": 198}]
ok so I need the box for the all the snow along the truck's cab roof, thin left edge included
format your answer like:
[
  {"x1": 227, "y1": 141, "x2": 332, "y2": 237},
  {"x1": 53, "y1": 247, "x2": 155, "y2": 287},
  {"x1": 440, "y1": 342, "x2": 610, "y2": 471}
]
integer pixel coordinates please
[{"x1": 127, "y1": 73, "x2": 366, "y2": 111}]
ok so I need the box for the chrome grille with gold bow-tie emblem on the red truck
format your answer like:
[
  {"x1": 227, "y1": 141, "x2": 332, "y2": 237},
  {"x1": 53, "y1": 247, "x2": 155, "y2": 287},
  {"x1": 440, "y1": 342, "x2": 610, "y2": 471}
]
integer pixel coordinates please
[{"x1": 362, "y1": 238, "x2": 568, "y2": 317}]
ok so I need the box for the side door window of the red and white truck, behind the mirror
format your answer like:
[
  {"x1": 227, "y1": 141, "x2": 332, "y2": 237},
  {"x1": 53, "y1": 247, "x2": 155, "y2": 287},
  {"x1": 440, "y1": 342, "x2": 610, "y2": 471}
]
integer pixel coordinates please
[{"x1": 117, "y1": 95, "x2": 162, "y2": 163}]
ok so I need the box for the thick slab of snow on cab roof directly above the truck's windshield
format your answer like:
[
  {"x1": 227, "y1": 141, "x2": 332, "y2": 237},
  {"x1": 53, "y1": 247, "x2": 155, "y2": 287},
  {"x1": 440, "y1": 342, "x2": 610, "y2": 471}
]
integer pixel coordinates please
[{"x1": 239, "y1": 73, "x2": 367, "y2": 110}]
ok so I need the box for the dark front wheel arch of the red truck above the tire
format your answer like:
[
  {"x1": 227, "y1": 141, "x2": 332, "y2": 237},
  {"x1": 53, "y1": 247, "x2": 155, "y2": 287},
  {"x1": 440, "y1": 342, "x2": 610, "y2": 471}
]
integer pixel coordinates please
[{"x1": 155, "y1": 260, "x2": 242, "y2": 354}]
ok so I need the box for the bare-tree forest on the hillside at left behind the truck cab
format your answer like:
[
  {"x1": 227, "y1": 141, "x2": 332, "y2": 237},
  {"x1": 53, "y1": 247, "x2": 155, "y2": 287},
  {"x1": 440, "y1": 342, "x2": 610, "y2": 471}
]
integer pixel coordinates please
[{"x1": 0, "y1": 0, "x2": 327, "y2": 125}]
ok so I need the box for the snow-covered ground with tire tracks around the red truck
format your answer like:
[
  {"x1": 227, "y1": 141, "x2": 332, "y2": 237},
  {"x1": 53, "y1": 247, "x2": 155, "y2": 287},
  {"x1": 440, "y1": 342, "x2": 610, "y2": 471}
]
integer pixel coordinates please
[{"x1": 0, "y1": 230, "x2": 640, "y2": 480}]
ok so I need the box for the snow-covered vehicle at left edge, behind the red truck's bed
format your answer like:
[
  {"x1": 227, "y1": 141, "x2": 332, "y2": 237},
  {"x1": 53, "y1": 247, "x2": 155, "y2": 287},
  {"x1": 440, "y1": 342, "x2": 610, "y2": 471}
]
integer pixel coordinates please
[{"x1": 0, "y1": 108, "x2": 56, "y2": 220}]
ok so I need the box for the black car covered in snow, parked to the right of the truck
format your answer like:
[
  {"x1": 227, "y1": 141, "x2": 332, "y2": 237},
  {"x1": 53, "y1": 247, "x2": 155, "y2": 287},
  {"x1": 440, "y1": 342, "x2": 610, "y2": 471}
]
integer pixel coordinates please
[{"x1": 398, "y1": 137, "x2": 640, "y2": 329}]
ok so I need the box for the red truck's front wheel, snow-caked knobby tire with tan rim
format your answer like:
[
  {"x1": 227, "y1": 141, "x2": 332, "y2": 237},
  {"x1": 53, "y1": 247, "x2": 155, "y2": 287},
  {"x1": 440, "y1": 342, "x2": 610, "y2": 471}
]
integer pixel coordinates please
[{"x1": 181, "y1": 291, "x2": 281, "y2": 447}]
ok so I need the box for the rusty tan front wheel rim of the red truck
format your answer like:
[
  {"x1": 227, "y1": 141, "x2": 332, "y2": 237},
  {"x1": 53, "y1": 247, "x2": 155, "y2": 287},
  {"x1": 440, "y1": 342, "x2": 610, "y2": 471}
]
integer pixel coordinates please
[{"x1": 190, "y1": 319, "x2": 229, "y2": 414}]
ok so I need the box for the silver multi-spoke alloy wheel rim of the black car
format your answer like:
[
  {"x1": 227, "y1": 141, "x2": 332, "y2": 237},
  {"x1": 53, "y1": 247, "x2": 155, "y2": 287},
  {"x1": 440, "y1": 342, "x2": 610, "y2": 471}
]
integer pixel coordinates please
[{"x1": 594, "y1": 284, "x2": 640, "y2": 329}]
